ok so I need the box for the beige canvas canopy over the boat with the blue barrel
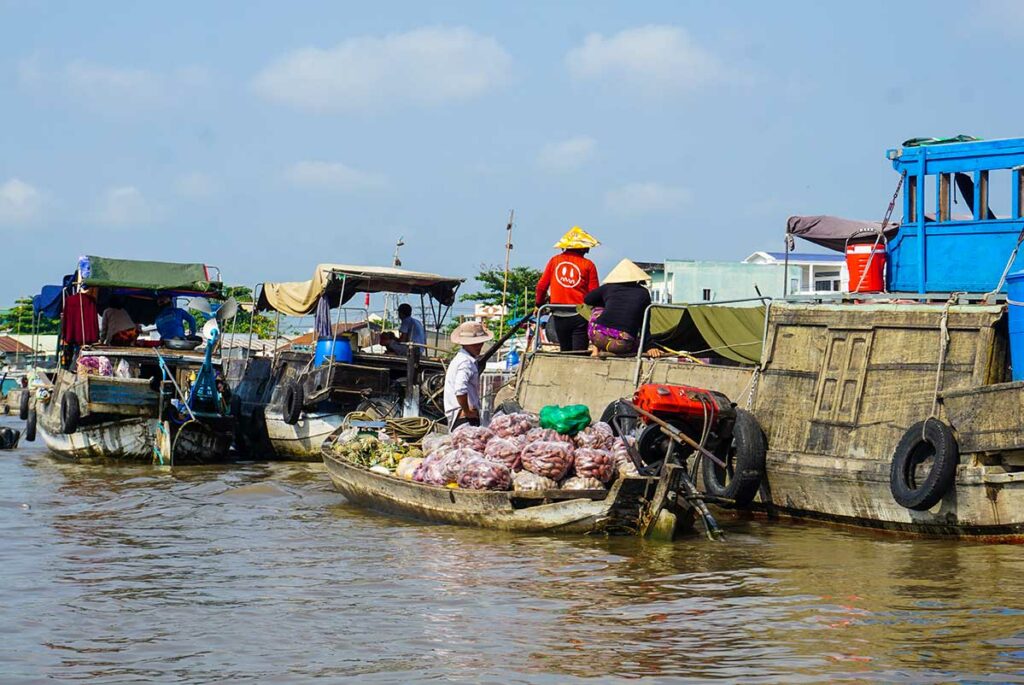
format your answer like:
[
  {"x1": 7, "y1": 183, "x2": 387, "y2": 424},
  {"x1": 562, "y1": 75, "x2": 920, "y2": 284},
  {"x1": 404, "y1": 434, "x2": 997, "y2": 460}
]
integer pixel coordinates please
[{"x1": 257, "y1": 264, "x2": 463, "y2": 316}]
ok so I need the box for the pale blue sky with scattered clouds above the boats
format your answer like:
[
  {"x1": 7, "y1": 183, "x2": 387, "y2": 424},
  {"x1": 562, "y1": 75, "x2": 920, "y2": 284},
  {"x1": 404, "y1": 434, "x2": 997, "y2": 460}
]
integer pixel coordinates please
[{"x1": 0, "y1": 0, "x2": 1024, "y2": 307}]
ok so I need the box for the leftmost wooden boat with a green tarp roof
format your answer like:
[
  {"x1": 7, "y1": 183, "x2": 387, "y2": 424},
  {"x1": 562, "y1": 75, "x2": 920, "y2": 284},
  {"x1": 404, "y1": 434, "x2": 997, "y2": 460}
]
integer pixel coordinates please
[{"x1": 26, "y1": 257, "x2": 234, "y2": 465}]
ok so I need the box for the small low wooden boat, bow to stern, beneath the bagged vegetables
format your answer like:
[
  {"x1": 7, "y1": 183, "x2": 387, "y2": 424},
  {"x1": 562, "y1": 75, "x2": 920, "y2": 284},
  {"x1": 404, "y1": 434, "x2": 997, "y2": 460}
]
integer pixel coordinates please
[{"x1": 322, "y1": 434, "x2": 695, "y2": 540}]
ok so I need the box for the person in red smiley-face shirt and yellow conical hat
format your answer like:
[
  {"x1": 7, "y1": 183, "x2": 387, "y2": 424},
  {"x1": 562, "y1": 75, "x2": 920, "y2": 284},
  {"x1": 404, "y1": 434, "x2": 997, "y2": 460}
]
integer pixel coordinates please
[{"x1": 537, "y1": 226, "x2": 600, "y2": 352}]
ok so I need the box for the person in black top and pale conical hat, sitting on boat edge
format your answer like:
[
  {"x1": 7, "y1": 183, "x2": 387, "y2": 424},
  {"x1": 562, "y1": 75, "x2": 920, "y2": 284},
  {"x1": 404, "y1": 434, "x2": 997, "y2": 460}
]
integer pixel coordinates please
[{"x1": 583, "y1": 259, "x2": 650, "y2": 354}]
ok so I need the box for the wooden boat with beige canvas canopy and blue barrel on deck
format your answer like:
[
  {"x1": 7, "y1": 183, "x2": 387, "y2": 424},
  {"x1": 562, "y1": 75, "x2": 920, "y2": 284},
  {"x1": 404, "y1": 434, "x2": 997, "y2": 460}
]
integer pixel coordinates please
[{"x1": 238, "y1": 264, "x2": 462, "y2": 462}]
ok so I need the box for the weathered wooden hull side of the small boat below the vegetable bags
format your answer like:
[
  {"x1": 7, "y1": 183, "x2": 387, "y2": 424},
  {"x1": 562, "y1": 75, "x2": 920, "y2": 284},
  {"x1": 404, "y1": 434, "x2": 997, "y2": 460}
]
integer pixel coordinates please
[{"x1": 324, "y1": 452, "x2": 667, "y2": 534}]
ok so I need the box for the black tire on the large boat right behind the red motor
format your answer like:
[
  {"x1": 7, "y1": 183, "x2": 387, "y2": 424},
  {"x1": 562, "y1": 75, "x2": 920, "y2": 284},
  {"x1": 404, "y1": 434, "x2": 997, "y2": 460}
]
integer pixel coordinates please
[{"x1": 700, "y1": 409, "x2": 767, "y2": 507}]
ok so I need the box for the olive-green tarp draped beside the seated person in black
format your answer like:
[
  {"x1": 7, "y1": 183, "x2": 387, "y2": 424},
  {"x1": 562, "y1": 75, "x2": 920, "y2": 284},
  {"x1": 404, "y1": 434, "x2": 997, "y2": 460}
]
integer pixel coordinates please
[{"x1": 650, "y1": 305, "x2": 765, "y2": 363}]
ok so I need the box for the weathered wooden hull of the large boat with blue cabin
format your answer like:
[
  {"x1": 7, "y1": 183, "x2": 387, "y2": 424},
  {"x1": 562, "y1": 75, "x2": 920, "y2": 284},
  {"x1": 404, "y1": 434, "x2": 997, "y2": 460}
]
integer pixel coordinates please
[{"x1": 496, "y1": 296, "x2": 1024, "y2": 542}]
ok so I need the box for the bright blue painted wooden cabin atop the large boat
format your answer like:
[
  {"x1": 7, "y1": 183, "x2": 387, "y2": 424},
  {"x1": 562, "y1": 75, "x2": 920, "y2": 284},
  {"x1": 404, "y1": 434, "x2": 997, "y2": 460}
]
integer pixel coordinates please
[{"x1": 887, "y1": 138, "x2": 1024, "y2": 293}]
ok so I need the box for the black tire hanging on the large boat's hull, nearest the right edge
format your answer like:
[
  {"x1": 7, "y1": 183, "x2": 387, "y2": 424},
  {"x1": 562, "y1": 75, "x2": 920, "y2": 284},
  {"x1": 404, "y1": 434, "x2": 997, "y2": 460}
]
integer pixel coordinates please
[{"x1": 889, "y1": 419, "x2": 959, "y2": 511}]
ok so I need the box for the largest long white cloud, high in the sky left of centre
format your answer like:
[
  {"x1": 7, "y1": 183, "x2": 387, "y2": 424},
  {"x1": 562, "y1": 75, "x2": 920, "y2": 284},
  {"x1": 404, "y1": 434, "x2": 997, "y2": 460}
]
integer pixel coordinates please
[{"x1": 252, "y1": 28, "x2": 512, "y2": 112}]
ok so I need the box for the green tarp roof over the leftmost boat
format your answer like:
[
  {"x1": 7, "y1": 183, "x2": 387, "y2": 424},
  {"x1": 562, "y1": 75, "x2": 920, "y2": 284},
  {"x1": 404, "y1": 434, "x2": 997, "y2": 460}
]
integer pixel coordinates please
[{"x1": 83, "y1": 256, "x2": 222, "y2": 294}]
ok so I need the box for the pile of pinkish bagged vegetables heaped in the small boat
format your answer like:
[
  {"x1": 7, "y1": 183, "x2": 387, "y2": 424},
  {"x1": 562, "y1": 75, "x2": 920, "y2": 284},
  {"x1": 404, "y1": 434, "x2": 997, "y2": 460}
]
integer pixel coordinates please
[{"x1": 332, "y1": 414, "x2": 637, "y2": 491}]
